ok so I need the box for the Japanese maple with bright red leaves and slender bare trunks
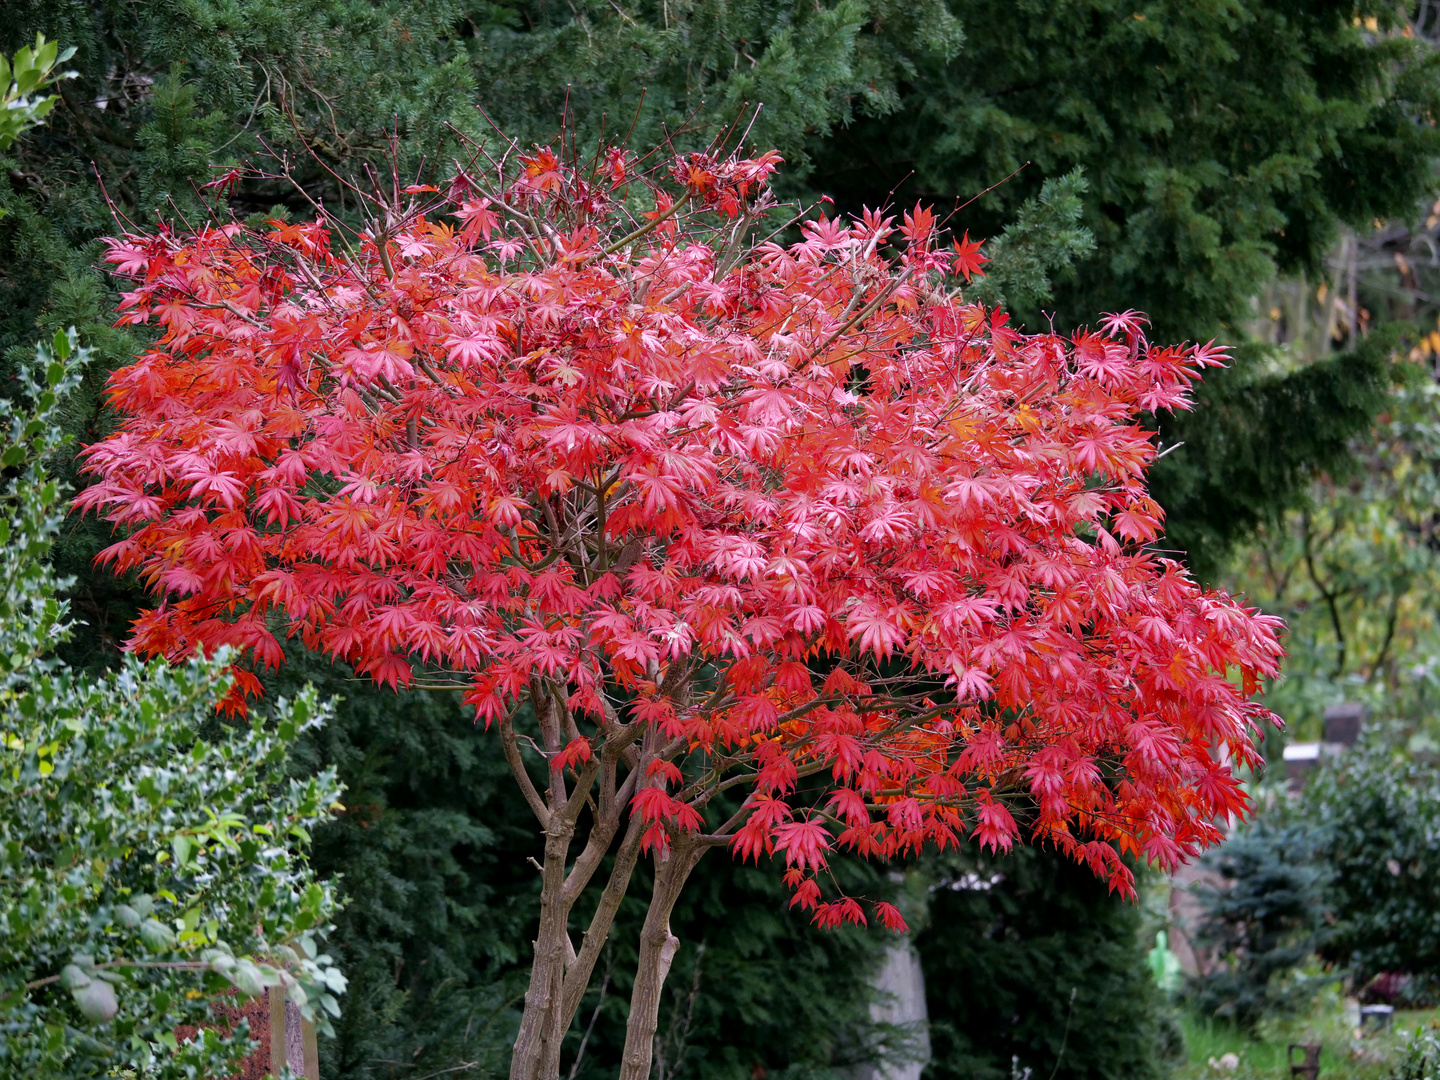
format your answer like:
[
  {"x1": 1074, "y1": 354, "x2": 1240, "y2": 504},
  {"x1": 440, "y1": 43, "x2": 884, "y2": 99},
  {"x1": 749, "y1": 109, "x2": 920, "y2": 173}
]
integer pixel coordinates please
[{"x1": 76, "y1": 135, "x2": 1280, "y2": 1080}]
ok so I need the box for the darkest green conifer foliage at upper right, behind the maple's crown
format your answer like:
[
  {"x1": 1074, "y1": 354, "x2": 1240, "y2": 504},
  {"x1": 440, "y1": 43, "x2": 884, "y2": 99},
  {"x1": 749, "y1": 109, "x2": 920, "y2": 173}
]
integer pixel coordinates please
[{"x1": 812, "y1": 0, "x2": 1440, "y2": 576}]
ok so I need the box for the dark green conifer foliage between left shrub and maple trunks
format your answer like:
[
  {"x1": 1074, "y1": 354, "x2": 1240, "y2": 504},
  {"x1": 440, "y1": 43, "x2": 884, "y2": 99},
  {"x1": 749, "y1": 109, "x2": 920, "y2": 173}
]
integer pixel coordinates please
[{"x1": 268, "y1": 655, "x2": 540, "y2": 1080}]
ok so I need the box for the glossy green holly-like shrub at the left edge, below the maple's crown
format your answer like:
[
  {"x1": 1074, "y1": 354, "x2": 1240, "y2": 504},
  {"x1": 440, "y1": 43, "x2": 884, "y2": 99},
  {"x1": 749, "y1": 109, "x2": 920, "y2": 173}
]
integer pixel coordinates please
[{"x1": 0, "y1": 331, "x2": 344, "y2": 1080}]
